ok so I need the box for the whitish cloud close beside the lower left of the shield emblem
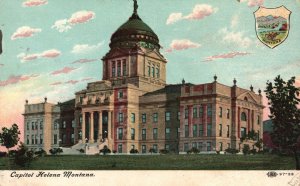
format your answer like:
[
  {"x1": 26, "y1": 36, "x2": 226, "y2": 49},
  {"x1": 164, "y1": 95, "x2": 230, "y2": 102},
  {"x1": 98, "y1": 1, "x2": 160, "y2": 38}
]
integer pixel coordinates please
[{"x1": 219, "y1": 28, "x2": 252, "y2": 48}]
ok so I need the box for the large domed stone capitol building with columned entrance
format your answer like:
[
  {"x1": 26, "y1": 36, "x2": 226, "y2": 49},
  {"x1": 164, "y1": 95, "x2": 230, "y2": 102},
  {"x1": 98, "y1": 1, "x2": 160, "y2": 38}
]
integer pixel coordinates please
[{"x1": 23, "y1": 2, "x2": 263, "y2": 154}]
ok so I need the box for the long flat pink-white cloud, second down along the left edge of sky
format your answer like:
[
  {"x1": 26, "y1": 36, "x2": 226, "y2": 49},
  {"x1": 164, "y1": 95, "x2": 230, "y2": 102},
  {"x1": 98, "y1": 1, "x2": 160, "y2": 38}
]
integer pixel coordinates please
[{"x1": 17, "y1": 49, "x2": 61, "y2": 63}]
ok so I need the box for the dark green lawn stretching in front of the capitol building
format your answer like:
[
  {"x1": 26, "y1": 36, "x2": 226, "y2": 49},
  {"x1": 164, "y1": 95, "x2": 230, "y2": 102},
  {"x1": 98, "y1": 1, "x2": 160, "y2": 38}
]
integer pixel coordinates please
[{"x1": 0, "y1": 154, "x2": 295, "y2": 170}]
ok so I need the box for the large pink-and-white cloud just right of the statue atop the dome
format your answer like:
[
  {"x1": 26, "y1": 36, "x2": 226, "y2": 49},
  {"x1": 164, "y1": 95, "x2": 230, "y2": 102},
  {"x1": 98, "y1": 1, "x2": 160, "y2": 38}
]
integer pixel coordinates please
[{"x1": 166, "y1": 4, "x2": 218, "y2": 25}]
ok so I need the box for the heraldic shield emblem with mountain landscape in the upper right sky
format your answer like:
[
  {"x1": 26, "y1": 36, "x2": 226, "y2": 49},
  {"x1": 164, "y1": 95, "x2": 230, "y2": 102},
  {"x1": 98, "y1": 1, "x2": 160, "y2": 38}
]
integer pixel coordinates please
[{"x1": 254, "y1": 6, "x2": 291, "y2": 48}]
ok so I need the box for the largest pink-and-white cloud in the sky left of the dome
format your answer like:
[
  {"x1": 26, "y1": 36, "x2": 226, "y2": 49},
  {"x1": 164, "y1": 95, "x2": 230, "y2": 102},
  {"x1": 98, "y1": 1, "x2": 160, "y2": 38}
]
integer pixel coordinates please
[{"x1": 51, "y1": 10, "x2": 96, "y2": 32}]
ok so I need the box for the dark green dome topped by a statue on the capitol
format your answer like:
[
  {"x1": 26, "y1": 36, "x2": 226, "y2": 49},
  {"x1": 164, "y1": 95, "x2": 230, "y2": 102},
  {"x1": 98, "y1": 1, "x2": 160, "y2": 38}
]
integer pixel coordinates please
[{"x1": 109, "y1": 2, "x2": 160, "y2": 49}]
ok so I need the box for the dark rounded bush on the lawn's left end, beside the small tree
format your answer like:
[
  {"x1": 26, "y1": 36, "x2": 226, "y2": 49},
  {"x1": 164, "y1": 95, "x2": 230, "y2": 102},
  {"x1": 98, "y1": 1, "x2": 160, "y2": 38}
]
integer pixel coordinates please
[{"x1": 14, "y1": 143, "x2": 34, "y2": 167}]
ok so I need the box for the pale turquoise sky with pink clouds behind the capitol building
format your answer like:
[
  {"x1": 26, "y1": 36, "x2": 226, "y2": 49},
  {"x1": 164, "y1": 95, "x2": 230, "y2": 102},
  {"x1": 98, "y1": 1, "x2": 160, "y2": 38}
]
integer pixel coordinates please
[{"x1": 0, "y1": 0, "x2": 300, "y2": 144}]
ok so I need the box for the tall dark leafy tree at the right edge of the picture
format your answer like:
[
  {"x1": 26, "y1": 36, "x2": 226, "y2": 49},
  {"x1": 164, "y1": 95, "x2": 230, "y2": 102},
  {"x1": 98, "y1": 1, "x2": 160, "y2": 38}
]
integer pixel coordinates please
[{"x1": 265, "y1": 76, "x2": 300, "y2": 170}]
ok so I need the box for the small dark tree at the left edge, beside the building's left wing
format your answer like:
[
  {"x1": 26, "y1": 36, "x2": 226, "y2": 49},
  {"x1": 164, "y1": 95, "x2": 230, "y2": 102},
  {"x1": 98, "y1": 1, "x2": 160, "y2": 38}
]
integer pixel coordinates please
[{"x1": 0, "y1": 124, "x2": 21, "y2": 152}]
